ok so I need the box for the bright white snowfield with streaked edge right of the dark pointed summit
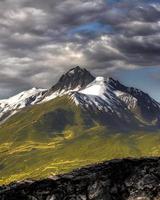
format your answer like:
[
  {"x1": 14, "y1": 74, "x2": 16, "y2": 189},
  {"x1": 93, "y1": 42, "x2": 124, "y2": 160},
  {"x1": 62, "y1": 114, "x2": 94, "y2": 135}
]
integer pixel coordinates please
[{"x1": 70, "y1": 77, "x2": 125, "y2": 115}]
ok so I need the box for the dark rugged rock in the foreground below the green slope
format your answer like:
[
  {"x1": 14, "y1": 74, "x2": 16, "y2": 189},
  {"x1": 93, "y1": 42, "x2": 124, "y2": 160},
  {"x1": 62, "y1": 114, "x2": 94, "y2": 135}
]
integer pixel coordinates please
[{"x1": 0, "y1": 158, "x2": 160, "y2": 200}]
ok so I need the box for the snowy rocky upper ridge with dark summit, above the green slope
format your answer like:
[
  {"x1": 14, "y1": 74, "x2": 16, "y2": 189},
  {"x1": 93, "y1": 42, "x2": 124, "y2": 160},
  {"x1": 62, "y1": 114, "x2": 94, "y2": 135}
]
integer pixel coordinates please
[{"x1": 0, "y1": 66, "x2": 160, "y2": 128}]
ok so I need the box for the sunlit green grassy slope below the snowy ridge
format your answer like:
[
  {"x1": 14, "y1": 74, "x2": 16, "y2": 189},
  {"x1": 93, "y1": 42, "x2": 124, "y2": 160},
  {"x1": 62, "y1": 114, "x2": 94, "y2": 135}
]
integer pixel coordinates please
[{"x1": 0, "y1": 97, "x2": 160, "y2": 184}]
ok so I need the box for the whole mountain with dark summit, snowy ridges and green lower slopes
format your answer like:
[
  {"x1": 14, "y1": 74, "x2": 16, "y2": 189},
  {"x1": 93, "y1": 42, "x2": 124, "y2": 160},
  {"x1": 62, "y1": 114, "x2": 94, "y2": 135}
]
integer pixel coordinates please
[{"x1": 0, "y1": 67, "x2": 160, "y2": 184}]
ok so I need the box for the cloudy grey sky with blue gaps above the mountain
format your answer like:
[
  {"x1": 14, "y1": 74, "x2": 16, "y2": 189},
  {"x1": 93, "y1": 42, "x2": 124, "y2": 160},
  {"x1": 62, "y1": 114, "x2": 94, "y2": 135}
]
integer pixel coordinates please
[{"x1": 0, "y1": 0, "x2": 160, "y2": 101}]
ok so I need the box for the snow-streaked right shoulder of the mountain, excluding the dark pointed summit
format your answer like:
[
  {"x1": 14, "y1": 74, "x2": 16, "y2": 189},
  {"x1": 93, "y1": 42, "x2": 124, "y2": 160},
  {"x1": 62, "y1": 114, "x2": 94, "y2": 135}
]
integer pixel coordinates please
[{"x1": 72, "y1": 77, "x2": 160, "y2": 129}]
